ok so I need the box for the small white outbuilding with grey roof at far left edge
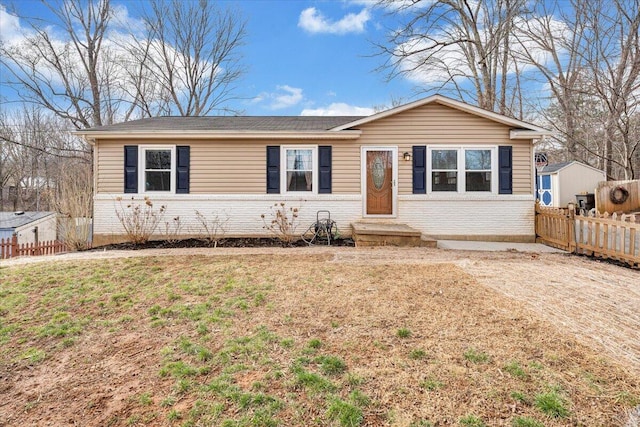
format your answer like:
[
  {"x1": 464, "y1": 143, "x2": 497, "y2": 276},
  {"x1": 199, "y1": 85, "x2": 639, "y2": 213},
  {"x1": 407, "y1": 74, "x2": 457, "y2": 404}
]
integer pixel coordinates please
[{"x1": 0, "y1": 212, "x2": 57, "y2": 245}]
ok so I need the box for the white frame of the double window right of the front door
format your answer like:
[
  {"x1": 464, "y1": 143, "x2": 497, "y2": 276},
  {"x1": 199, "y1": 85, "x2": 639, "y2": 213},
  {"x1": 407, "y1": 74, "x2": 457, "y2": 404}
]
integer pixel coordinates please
[{"x1": 427, "y1": 145, "x2": 499, "y2": 195}]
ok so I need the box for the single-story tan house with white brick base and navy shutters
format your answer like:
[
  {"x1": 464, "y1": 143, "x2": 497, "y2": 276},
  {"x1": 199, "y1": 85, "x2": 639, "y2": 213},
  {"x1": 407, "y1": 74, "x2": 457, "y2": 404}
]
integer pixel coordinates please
[{"x1": 77, "y1": 95, "x2": 549, "y2": 246}]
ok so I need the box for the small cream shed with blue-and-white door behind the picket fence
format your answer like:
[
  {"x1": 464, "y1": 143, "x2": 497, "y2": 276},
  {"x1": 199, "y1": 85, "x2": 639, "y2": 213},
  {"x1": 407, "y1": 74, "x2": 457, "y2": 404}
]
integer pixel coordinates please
[{"x1": 538, "y1": 161, "x2": 607, "y2": 208}]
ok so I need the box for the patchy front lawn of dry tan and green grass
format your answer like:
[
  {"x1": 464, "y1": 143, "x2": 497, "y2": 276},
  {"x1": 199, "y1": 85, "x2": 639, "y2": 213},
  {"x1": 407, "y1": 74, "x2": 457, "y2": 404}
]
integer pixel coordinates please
[{"x1": 0, "y1": 252, "x2": 640, "y2": 427}]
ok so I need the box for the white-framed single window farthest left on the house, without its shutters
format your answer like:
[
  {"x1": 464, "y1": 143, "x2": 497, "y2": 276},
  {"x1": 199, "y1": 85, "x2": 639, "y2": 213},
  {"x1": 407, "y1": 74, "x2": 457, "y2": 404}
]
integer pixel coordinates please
[{"x1": 138, "y1": 145, "x2": 176, "y2": 193}]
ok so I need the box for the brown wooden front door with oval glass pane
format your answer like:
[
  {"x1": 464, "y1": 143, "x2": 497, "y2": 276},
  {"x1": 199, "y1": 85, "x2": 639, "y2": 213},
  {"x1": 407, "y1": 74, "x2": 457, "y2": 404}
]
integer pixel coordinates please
[{"x1": 365, "y1": 149, "x2": 394, "y2": 215}]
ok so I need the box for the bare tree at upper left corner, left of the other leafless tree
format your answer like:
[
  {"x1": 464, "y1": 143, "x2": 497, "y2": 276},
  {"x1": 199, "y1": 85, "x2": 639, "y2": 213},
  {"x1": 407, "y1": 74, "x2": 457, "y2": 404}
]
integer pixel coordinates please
[{"x1": 0, "y1": 0, "x2": 111, "y2": 129}]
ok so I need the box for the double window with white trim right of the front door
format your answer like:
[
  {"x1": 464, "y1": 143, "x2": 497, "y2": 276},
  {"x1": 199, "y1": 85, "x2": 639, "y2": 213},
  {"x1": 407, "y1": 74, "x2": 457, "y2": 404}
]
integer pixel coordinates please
[{"x1": 427, "y1": 146, "x2": 498, "y2": 193}]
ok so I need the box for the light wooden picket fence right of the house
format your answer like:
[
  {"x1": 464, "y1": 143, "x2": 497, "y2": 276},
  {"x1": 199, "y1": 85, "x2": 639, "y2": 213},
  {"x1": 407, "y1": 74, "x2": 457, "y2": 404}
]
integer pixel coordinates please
[{"x1": 536, "y1": 203, "x2": 640, "y2": 267}]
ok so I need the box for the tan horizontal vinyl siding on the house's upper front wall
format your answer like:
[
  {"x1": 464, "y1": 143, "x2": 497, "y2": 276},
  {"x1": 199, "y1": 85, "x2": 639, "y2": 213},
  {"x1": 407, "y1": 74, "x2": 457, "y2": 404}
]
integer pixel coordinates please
[{"x1": 96, "y1": 103, "x2": 533, "y2": 194}]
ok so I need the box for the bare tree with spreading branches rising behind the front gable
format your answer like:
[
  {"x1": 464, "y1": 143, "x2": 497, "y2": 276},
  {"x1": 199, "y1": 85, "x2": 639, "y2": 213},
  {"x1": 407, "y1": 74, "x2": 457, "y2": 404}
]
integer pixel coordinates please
[{"x1": 378, "y1": 0, "x2": 525, "y2": 116}]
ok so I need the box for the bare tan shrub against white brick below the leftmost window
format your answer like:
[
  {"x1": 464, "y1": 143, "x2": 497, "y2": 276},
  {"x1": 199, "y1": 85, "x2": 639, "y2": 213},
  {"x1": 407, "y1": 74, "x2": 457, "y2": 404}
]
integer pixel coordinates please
[{"x1": 116, "y1": 197, "x2": 167, "y2": 244}]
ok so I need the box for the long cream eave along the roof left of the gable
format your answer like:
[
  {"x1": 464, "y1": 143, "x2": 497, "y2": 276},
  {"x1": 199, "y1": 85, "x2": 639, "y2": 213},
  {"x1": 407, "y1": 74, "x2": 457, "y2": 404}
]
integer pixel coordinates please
[{"x1": 73, "y1": 130, "x2": 362, "y2": 144}]
